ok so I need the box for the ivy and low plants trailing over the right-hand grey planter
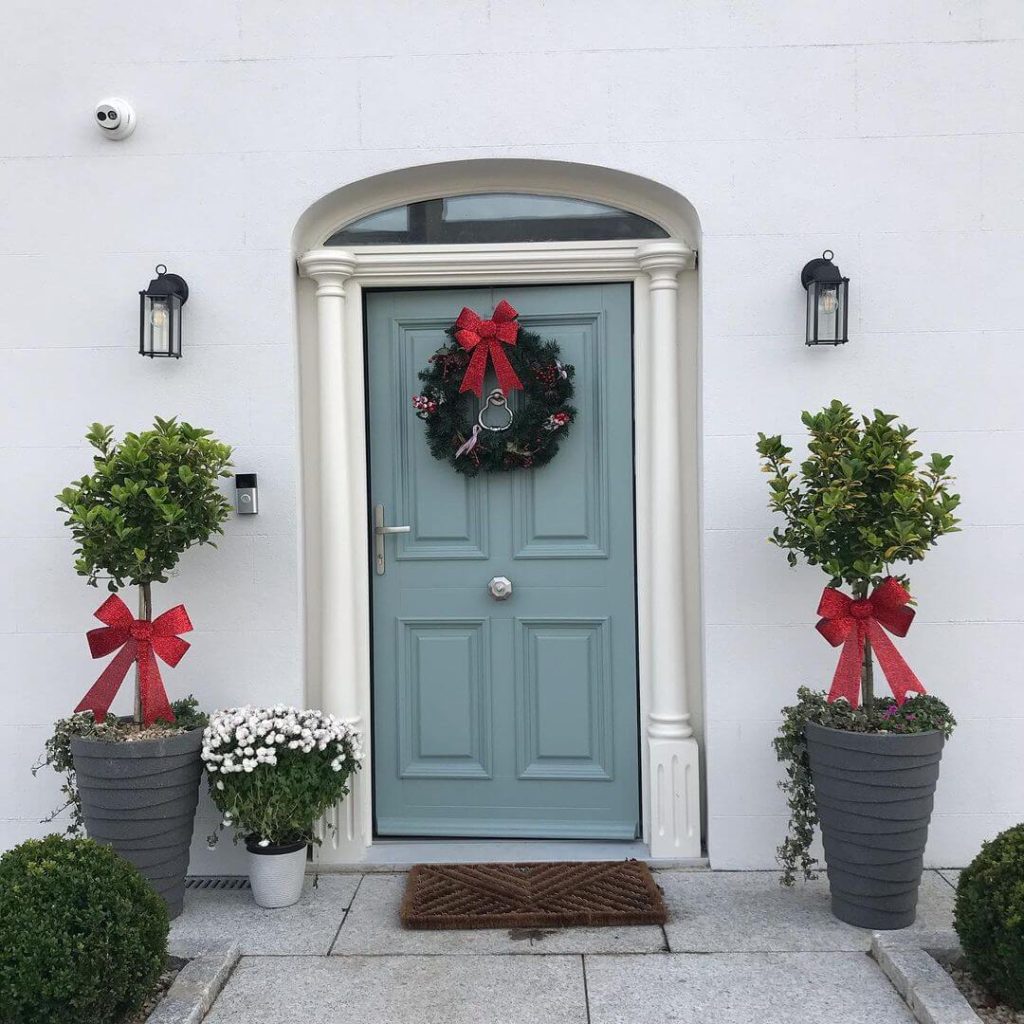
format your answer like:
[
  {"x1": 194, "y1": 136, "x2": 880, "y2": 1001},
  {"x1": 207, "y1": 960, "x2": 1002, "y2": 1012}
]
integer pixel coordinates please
[{"x1": 772, "y1": 686, "x2": 956, "y2": 886}]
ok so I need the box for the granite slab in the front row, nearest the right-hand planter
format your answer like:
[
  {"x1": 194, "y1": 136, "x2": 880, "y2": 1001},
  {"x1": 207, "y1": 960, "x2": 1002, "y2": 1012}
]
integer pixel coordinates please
[{"x1": 581, "y1": 952, "x2": 913, "y2": 1024}]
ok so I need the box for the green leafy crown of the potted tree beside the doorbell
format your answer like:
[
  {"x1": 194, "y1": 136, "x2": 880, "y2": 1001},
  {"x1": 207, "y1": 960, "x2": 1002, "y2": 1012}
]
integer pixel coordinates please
[{"x1": 56, "y1": 417, "x2": 231, "y2": 591}]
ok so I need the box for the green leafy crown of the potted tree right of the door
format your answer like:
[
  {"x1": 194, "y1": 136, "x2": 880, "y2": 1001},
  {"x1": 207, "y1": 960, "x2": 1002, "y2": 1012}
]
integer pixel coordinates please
[{"x1": 757, "y1": 400, "x2": 959, "y2": 594}]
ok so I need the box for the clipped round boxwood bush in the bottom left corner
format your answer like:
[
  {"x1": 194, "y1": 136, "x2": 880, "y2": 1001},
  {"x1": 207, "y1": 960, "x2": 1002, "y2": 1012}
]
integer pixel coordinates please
[{"x1": 0, "y1": 836, "x2": 168, "y2": 1024}]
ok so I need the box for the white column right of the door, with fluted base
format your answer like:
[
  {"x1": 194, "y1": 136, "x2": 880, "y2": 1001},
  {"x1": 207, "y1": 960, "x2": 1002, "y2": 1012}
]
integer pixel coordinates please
[{"x1": 637, "y1": 240, "x2": 700, "y2": 858}]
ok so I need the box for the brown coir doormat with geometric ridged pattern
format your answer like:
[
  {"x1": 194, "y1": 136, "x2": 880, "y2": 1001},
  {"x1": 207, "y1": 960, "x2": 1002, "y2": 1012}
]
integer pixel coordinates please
[{"x1": 401, "y1": 860, "x2": 668, "y2": 930}]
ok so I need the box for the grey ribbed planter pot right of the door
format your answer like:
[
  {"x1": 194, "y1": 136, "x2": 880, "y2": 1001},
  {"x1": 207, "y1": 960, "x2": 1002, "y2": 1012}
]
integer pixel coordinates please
[{"x1": 806, "y1": 722, "x2": 944, "y2": 931}]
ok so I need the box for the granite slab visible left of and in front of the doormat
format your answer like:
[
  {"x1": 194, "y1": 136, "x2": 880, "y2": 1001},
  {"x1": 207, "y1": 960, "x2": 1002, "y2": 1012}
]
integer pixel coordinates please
[{"x1": 331, "y1": 874, "x2": 666, "y2": 956}]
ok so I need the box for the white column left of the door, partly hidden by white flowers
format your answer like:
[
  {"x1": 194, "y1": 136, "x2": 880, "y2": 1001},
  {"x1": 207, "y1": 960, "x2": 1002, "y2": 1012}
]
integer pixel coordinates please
[{"x1": 299, "y1": 250, "x2": 371, "y2": 862}]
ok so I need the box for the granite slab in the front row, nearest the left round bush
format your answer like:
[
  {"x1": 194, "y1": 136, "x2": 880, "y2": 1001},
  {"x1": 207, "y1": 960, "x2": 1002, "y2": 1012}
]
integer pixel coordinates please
[{"x1": 205, "y1": 956, "x2": 589, "y2": 1024}]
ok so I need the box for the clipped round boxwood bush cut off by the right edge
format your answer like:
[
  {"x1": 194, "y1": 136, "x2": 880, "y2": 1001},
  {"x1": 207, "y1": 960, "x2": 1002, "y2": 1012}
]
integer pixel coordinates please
[{"x1": 954, "y1": 824, "x2": 1024, "y2": 1010}]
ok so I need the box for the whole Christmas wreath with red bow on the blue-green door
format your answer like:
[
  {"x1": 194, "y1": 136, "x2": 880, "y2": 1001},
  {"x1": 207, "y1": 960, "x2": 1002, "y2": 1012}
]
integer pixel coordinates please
[{"x1": 413, "y1": 299, "x2": 577, "y2": 476}]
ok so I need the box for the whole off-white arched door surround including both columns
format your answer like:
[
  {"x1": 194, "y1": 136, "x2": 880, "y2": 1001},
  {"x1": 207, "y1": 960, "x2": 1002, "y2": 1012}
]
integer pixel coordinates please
[{"x1": 295, "y1": 161, "x2": 701, "y2": 865}]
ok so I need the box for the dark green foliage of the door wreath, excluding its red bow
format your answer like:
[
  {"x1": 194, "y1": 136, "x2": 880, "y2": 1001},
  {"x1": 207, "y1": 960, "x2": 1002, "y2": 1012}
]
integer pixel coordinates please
[{"x1": 417, "y1": 328, "x2": 577, "y2": 476}]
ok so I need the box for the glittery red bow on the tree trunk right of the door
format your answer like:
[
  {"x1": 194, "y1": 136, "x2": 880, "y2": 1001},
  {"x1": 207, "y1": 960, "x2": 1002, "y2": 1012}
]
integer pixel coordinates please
[{"x1": 815, "y1": 577, "x2": 925, "y2": 708}]
